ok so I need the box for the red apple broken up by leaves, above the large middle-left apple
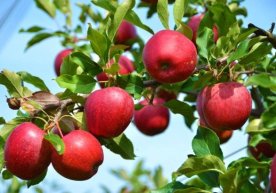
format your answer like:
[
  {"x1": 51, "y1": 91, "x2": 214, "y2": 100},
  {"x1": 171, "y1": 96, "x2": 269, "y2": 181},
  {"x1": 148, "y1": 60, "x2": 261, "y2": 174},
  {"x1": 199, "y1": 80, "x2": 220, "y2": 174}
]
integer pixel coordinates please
[{"x1": 97, "y1": 56, "x2": 135, "y2": 88}]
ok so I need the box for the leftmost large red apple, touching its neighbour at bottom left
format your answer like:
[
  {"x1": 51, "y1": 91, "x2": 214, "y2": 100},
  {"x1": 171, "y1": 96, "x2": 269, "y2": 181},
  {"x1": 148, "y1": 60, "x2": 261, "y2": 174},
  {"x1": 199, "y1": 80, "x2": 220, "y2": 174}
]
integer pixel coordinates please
[{"x1": 4, "y1": 122, "x2": 51, "y2": 180}]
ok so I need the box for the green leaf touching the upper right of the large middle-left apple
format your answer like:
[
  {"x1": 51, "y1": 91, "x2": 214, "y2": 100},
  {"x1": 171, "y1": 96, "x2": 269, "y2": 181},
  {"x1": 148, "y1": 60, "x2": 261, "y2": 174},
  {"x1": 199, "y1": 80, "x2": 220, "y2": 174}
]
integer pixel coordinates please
[{"x1": 117, "y1": 74, "x2": 144, "y2": 99}]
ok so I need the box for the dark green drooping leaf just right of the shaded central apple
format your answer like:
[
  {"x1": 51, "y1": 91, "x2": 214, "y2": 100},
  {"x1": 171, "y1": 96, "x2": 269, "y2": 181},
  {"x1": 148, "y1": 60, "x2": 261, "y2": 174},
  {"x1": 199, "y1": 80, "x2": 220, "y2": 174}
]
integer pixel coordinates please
[{"x1": 165, "y1": 100, "x2": 196, "y2": 127}]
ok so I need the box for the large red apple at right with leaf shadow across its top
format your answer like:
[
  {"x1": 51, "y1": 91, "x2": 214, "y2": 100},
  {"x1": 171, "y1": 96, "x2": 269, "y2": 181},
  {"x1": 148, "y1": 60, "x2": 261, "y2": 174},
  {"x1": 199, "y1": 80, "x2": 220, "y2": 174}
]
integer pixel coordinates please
[{"x1": 201, "y1": 82, "x2": 252, "y2": 130}]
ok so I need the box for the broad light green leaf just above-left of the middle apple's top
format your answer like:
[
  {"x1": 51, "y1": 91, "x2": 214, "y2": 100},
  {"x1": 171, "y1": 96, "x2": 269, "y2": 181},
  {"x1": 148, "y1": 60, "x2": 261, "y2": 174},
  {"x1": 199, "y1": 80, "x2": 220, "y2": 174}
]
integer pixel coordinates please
[{"x1": 56, "y1": 74, "x2": 96, "y2": 94}]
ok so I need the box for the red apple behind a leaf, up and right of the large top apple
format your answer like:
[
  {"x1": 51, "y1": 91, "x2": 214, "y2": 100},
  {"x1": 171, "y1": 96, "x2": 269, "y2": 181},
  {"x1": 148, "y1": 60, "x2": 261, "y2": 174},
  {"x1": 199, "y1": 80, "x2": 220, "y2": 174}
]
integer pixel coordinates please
[{"x1": 188, "y1": 14, "x2": 218, "y2": 43}]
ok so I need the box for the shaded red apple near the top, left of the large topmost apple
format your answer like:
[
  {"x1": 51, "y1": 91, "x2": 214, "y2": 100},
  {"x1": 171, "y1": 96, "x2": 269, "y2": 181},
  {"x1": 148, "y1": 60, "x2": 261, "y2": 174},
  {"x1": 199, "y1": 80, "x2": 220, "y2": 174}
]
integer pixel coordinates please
[{"x1": 115, "y1": 20, "x2": 137, "y2": 45}]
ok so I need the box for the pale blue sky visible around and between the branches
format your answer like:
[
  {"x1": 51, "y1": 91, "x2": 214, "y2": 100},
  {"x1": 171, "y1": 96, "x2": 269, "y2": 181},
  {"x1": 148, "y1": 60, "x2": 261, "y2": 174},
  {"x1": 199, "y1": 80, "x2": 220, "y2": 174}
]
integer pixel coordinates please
[{"x1": 0, "y1": 0, "x2": 276, "y2": 193}]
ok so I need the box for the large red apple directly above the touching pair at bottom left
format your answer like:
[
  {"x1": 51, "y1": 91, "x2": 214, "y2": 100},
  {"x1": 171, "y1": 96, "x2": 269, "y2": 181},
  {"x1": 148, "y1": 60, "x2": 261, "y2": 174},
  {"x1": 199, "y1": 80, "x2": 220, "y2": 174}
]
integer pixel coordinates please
[{"x1": 84, "y1": 87, "x2": 134, "y2": 138}]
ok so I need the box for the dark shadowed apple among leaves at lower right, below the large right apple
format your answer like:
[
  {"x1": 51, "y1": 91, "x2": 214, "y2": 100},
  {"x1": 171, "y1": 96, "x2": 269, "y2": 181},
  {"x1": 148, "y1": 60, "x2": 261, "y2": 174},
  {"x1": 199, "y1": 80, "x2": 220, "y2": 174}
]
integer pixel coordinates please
[{"x1": 249, "y1": 138, "x2": 276, "y2": 160}]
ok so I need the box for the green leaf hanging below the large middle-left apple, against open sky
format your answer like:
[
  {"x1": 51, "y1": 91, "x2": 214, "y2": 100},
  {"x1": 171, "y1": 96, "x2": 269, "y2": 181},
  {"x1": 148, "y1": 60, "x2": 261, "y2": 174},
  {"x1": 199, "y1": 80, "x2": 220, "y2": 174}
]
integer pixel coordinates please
[{"x1": 100, "y1": 134, "x2": 136, "y2": 160}]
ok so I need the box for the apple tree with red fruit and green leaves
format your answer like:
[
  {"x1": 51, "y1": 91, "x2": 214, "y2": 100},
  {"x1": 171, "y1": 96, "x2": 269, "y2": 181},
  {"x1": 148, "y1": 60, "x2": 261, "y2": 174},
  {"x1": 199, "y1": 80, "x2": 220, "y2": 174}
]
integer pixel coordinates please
[{"x1": 0, "y1": 0, "x2": 276, "y2": 193}]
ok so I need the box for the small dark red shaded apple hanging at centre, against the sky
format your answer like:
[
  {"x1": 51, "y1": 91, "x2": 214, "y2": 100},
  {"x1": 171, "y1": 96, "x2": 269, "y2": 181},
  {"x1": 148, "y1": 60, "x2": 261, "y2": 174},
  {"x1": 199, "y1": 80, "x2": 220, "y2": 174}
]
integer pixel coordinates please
[{"x1": 134, "y1": 98, "x2": 170, "y2": 136}]
